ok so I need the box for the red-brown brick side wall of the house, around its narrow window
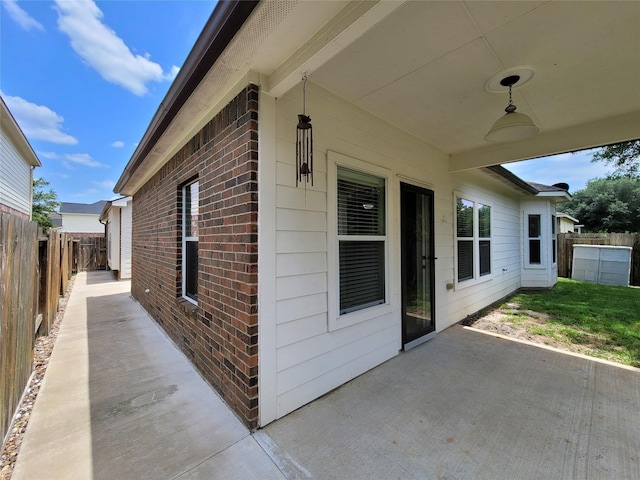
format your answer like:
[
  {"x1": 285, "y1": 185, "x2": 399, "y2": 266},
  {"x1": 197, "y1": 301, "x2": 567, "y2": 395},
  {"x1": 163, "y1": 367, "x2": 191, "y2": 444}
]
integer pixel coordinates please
[{"x1": 132, "y1": 85, "x2": 258, "y2": 428}]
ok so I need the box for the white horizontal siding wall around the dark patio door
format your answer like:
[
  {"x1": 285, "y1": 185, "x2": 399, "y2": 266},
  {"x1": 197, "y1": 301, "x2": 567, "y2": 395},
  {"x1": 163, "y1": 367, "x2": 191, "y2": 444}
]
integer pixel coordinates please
[{"x1": 258, "y1": 82, "x2": 540, "y2": 424}]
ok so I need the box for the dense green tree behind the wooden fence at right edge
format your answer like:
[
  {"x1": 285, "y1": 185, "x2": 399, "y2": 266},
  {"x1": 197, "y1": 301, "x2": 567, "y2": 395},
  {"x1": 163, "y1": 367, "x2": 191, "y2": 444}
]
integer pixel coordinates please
[{"x1": 558, "y1": 177, "x2": 640, "y2": 233}]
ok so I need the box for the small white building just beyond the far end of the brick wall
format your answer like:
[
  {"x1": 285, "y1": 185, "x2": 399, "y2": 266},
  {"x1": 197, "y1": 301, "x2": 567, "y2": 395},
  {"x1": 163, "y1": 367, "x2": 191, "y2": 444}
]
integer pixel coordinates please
[{"x1": 100, "y1": 197, "x2": 133, "y2": 280}]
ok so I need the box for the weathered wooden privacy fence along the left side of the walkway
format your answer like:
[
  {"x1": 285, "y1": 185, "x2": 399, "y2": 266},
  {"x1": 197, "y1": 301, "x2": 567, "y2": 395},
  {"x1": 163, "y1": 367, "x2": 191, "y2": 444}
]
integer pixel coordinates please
[{"x1": 0, "y1": 214, "x2": 71, "y2": 444}]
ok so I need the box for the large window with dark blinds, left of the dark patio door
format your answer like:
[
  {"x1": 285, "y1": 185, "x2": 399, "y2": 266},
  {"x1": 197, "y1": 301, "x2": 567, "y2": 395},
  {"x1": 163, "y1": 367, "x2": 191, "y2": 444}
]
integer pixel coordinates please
[{"x1": 337, "y1": 166, "x2": 387, "y2": 315}]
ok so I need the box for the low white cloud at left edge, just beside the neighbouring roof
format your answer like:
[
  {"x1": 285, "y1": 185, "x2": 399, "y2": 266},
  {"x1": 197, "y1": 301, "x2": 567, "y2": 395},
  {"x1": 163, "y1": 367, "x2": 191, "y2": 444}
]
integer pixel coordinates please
[{"x1": 3, "y1": 93, "x2": 78, "y2": 145}]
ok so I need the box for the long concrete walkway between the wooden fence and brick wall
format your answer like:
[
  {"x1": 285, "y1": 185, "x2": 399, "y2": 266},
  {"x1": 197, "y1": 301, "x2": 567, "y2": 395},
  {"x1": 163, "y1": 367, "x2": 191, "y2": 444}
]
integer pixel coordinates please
[{"x1": 12, "y1": 272, "x2": 284, "y2": 480}]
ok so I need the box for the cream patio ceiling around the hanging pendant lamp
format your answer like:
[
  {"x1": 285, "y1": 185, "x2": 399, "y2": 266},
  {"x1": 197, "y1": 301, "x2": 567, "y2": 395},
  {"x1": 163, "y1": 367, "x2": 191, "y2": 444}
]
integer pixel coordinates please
[{"x1": 262, "y1": 1, "x2": 640, "y2": 171}]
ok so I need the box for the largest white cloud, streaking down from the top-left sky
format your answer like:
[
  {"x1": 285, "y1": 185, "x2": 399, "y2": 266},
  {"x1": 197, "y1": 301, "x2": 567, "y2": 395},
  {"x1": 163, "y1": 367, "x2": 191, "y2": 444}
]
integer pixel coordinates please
[{"x1": 56, "y1": 0, "x2": 177, "y2": 95}]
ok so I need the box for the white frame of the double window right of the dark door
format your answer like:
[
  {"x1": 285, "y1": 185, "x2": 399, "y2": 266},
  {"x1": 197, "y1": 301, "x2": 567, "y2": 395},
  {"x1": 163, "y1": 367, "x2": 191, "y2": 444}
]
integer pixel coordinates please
[{"x1": 453, "y1": 191, "x2": 495, "y2": 289}]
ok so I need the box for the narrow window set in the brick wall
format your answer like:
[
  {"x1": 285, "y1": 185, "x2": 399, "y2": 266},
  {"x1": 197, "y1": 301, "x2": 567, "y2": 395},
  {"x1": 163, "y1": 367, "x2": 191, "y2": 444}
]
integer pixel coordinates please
[{"x1": 182, "y1": 181, "x2": 199, "y2": 303}]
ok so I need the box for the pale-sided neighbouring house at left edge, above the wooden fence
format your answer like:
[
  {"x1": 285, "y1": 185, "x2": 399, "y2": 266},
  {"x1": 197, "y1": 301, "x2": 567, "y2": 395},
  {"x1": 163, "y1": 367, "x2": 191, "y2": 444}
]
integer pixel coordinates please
[{"x1": 0, "y1": 97, "x2": 42, "y2": 220}]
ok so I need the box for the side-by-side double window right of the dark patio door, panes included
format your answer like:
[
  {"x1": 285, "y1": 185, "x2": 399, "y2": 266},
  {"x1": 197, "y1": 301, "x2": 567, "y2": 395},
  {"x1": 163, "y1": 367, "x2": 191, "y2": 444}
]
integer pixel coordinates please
[{"x1": 456, "y1": 197, "x2": 491, "y2": 282}]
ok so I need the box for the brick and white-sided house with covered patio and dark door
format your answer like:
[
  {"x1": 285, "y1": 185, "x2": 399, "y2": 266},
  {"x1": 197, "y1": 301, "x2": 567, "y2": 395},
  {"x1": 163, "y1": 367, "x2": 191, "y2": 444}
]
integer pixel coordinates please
[{"x1": 115, "y1": 1, "x2": 640, "y2": 428}]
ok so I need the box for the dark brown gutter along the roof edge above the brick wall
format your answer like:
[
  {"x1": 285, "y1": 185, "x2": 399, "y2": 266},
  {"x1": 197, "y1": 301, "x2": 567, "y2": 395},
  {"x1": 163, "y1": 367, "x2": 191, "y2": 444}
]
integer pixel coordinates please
[{"x1": 113, "y1": 0, "x2": 260, "y2": 193}]
